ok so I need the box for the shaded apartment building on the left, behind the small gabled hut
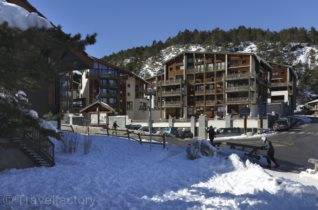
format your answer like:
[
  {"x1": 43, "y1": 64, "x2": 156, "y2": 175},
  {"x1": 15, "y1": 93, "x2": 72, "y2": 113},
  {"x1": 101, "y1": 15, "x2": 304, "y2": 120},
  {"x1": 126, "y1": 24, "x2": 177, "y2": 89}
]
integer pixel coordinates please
[{"x1": 60, "y1": 58, "x2": 147, "y2": 117}]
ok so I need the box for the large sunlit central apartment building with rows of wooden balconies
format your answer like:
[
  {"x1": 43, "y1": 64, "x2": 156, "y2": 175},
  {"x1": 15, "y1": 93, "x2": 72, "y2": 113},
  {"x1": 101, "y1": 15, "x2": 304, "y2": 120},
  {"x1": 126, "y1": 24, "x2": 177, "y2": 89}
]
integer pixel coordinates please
[{"x1": 148, "y1": 52, "x2": 271, "y2": 119}]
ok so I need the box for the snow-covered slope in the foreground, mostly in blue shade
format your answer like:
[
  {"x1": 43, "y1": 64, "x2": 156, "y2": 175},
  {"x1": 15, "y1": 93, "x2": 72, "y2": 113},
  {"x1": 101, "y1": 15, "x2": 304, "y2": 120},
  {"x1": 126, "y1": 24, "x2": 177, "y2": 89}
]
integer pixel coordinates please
[{"x1": 0, "y1": 134, "x2": 318, "y2": 209}]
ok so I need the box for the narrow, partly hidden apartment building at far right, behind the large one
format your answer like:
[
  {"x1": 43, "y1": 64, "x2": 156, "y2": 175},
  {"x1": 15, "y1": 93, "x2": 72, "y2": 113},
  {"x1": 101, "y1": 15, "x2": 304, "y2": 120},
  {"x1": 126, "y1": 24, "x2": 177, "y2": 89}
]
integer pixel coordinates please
[{"x1": 268, "y1": 63, "x2": 298, "y2": 115}]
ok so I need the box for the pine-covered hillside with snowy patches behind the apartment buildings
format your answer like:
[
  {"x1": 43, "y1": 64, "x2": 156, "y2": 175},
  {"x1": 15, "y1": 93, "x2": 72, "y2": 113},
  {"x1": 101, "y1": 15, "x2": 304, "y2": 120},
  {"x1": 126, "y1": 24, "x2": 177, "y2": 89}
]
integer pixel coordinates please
[{"x1": 103, "y1": 26, "x2": 318, "y2": 100}]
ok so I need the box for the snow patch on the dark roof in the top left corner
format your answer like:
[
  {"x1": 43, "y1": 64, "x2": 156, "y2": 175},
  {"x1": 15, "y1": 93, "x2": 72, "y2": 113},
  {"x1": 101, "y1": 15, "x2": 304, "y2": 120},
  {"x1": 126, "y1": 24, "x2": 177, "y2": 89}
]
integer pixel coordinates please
[{"x1": 0, "y1": 0, "x2": 52, "y2": 30}]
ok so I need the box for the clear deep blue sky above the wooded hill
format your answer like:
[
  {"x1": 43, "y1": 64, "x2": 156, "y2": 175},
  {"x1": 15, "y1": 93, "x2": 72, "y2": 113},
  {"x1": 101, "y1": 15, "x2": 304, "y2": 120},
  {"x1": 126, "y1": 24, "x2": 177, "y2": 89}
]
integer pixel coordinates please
[{"x1": 29, "y1": 0, "x2": 318, "y2": 57}]
